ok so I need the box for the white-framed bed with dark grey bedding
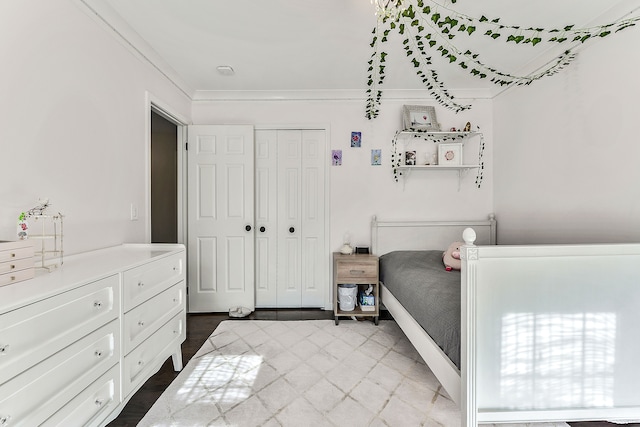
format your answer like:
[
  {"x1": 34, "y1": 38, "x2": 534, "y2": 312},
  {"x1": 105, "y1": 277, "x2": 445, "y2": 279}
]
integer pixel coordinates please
[{"x1": 371, "y1": 216, "x2": 640, "y2": 426}]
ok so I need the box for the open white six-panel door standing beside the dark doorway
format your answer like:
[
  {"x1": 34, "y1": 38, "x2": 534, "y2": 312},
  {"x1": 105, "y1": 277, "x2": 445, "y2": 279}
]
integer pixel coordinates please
[{"x1": 188, "y1": 125, "x2": 255, "y2": 312}]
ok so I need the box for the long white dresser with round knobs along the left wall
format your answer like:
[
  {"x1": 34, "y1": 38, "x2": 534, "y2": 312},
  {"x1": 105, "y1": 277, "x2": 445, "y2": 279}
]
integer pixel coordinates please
[{"x1": 0, "y1": 244, "x2": 186, "y2": 427}]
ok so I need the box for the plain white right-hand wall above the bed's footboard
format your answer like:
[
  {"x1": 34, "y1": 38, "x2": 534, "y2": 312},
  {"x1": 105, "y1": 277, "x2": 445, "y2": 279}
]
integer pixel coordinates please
[{"x1": 494, "y1": 27, "x2": 640, "y2": 244}]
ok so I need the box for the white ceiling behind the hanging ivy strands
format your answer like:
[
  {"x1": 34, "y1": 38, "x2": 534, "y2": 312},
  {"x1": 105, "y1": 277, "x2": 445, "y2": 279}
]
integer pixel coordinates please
[{"x1": 81, "y1": 0, "x2": 640, "y2": 98}]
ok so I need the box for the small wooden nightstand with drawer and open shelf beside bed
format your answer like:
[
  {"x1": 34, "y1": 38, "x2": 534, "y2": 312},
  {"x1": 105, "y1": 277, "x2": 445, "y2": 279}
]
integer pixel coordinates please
[{"x1": 333, "y1": 252, "x2": 380, "y2": 325}]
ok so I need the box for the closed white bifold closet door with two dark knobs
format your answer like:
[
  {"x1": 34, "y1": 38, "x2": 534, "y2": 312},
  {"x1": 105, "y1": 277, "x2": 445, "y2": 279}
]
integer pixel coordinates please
[{"x1": 256, "y1": 130, "x2": 328, "y2": 307}]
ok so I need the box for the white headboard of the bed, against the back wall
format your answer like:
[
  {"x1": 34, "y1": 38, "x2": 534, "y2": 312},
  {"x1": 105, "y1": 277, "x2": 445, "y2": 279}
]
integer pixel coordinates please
[{"x1": 371, "y1": 214, "x2": 496, "y2": 255}]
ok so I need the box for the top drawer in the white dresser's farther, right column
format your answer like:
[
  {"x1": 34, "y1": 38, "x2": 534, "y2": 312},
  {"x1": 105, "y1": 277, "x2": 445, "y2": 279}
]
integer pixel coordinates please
[{"x1": 123, "y1": 254, "x2": 184, "y2": 312}]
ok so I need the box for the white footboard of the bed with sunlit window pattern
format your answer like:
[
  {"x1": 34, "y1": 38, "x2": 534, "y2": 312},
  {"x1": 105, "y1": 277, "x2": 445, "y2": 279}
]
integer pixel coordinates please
[{"x1": 461, "y1": 234, "x2": 640, "y2": 426}]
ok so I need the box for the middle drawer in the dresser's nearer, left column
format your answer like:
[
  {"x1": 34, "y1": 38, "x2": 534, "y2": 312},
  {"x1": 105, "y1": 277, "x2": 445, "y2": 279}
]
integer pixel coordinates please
[{"x1": 0, "y1": 321, "x2": 119, "y2": 426}]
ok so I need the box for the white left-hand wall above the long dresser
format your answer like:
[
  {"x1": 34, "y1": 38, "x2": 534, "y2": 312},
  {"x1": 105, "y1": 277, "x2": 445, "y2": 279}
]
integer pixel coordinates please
[{"x1": 0, "y1": 0, "x2": 190, "y2": 253}]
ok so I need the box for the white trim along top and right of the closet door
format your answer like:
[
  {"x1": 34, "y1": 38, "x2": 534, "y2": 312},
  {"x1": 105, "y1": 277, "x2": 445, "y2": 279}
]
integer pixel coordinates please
[{"x1": 254, "y1": 123, "x2": 333, "y2": 310}]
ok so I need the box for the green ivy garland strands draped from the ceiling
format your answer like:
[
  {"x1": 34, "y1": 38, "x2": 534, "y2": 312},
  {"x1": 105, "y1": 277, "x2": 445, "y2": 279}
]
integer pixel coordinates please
[{"x1": 365, "y1": 0, "x2": 640, "y2": 119}]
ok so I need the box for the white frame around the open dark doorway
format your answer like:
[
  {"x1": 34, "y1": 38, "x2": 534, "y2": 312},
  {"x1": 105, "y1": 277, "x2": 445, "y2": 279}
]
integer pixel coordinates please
[{"x1": 144, "y1": 91, "x2": 189, "y2": 244}]
